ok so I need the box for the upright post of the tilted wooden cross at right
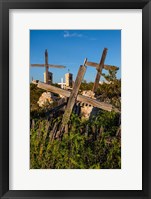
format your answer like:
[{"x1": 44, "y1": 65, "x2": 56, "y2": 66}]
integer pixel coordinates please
[{"x1": 92, "y1": 48, "x2": 107, "y2": 92}]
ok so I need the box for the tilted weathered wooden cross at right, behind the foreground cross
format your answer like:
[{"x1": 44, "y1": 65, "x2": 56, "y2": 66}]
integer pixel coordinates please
[{"x1": 85, "y1": 48, "x2": 118, "y2": 93}]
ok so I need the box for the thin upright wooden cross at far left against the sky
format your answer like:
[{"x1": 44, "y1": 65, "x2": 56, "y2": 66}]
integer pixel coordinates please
[{"x1": 31, "y1": 50, "x2": 65, "y2": 84}]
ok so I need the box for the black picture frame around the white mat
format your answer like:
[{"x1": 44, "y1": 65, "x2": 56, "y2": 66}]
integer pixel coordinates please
[{"x1": 0, "y1": 0, "x2": 151, "y2": 199}]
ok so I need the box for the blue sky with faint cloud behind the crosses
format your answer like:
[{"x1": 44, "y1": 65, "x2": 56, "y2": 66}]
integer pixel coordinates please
[{"x1": 30, "y1": 30, "x2": 121, "y2": 83}]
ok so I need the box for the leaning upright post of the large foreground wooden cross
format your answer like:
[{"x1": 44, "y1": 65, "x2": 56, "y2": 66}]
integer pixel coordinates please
[{"x1": 57, "y1": 64, "x2": 86, "y2": 137}]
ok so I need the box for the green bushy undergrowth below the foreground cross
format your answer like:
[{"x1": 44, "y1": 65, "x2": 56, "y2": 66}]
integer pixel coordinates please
[{"x1": 30, "y1": 112, "x2": 121, "y2": 169}]
